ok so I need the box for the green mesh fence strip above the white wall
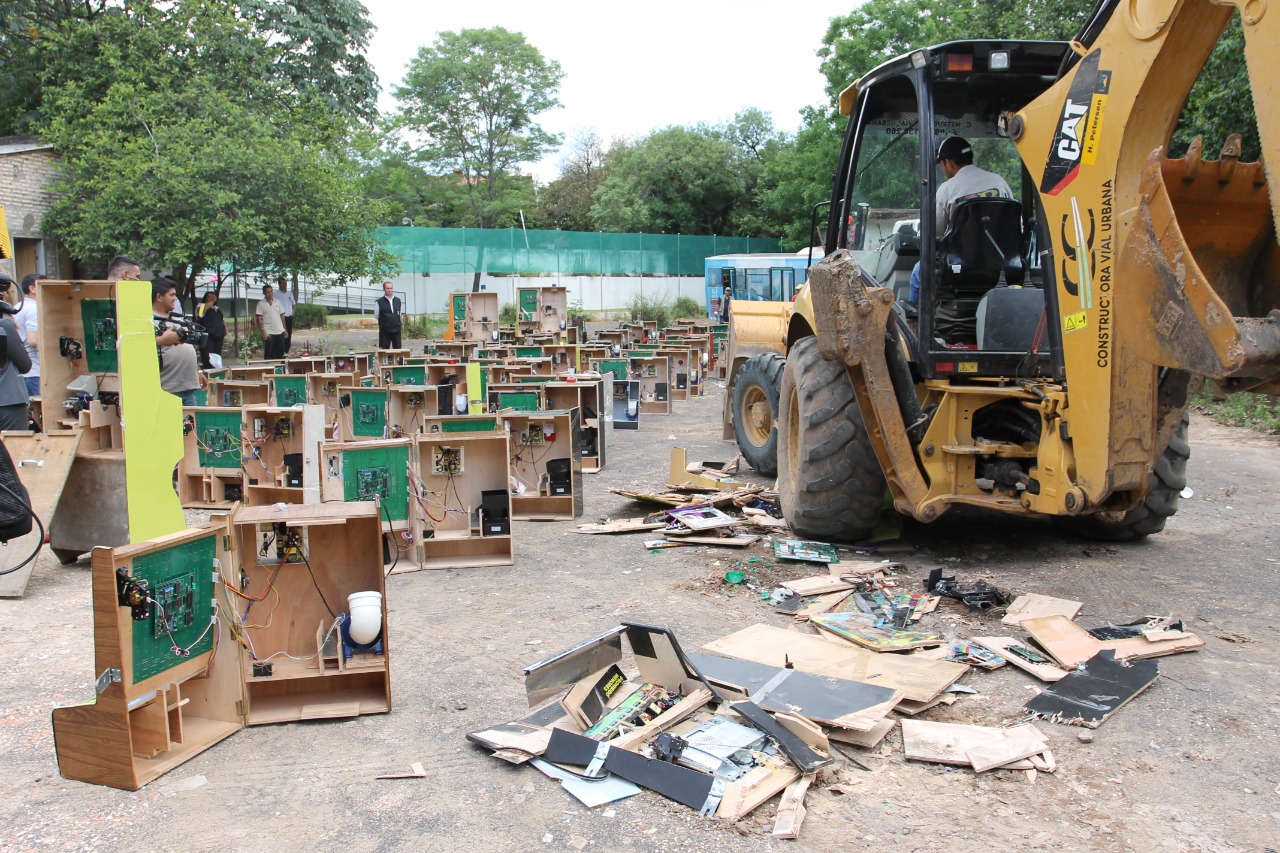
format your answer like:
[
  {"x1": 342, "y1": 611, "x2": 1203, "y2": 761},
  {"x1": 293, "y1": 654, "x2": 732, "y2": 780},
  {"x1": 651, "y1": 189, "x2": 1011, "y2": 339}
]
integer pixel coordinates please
[{"x1": 383, "y1": 228, "x2": 780, "y2": 277}]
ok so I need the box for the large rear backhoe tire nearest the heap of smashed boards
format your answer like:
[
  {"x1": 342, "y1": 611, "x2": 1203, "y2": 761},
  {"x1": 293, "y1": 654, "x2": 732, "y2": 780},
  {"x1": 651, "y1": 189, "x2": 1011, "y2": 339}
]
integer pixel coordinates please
[{"x1": 778, "y1": 338, "x2": 886, "y2": 542}]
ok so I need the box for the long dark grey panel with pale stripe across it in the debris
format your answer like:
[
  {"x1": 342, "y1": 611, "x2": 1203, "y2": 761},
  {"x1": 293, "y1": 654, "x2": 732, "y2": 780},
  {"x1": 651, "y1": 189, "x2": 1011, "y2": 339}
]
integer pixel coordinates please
[{"x1": 689, "y1": 653, "x2": 901, "y2": 731}]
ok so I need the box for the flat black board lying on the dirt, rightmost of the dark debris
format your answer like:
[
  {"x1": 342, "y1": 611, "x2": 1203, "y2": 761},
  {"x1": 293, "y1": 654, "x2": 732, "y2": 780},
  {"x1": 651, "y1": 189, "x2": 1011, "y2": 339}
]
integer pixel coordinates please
[{"x1": 1025, "y1": 640, "x2": 1160, "y2": 729}]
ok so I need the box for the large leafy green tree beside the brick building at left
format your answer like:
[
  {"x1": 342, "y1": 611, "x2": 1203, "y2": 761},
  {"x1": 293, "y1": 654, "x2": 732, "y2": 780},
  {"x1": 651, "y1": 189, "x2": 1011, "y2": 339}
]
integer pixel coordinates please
[{"x1": 41, "y1": 0, "x2": 393, "y2": 297}]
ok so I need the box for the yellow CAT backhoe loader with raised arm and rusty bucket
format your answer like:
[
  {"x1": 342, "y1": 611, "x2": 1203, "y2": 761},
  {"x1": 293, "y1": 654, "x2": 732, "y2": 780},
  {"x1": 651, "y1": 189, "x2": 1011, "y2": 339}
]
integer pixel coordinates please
[{"x1": 742, "y1": 0, "x2": 1280, "y2": 540}]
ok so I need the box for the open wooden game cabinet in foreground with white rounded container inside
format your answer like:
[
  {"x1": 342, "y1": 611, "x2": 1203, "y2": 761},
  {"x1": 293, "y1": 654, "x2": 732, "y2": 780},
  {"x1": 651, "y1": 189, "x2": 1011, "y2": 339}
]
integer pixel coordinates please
[{"x1": 52, "y1": 503, "x2": 392, "y2": 790}]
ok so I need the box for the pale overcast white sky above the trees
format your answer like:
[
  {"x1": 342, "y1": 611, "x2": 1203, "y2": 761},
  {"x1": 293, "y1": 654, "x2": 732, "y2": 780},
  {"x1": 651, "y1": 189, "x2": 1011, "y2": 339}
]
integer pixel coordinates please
[{"x1": 364, "y1": 0, "x2": 859, "y2": 183}]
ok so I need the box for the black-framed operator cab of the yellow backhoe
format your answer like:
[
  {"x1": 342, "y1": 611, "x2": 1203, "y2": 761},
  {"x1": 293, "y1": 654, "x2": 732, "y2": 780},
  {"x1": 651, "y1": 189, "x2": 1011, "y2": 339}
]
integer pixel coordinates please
[{"x1": 826, "y1": 41, "x2": 1071, "y2": 379}]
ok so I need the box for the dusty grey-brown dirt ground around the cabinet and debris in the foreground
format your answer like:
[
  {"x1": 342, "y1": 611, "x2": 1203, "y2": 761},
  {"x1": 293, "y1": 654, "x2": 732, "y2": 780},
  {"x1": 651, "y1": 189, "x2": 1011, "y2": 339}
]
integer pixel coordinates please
[{"x1": 0, "y1": 333, "x2": 1280, "y2": 853}]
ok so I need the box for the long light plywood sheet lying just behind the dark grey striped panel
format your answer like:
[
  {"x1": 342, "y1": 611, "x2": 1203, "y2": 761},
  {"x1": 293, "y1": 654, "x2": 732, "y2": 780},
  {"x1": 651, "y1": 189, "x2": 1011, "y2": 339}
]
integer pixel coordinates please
[{"x1": 703, "y1": 625, "x2": 969, "y2": 702}]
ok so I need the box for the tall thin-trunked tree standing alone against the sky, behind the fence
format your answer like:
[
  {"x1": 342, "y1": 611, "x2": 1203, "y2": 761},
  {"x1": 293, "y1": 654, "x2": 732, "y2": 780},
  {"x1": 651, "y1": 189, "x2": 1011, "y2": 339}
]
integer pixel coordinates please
[{"x1": 394, "y1": 27, "x2": 564, "y2": 289}]
